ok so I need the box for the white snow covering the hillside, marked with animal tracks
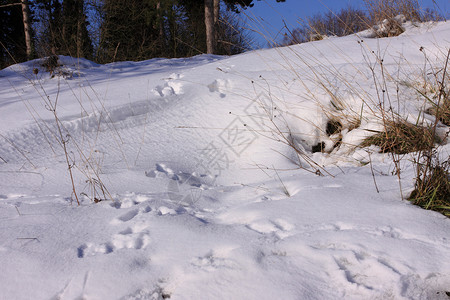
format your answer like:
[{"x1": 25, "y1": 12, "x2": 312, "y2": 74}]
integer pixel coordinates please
[{"x1": 0, "y1": 23, "x2": 450, "y2": 299}]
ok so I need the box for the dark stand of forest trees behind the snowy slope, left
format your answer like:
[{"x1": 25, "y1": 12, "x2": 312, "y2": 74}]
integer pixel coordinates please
[{"x1": 0, "y1": 0, "x2": 285, "y2": 68}]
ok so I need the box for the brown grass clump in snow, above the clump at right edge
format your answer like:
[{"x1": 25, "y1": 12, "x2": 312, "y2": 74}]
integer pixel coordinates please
[{"x1": 361, "y1": 121, "x2": 438, "y2": 154}]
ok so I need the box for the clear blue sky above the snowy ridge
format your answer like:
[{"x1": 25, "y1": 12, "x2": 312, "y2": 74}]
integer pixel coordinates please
[{"x1": 243, "y1": 0, "x2": 450, "y2": 46}]
